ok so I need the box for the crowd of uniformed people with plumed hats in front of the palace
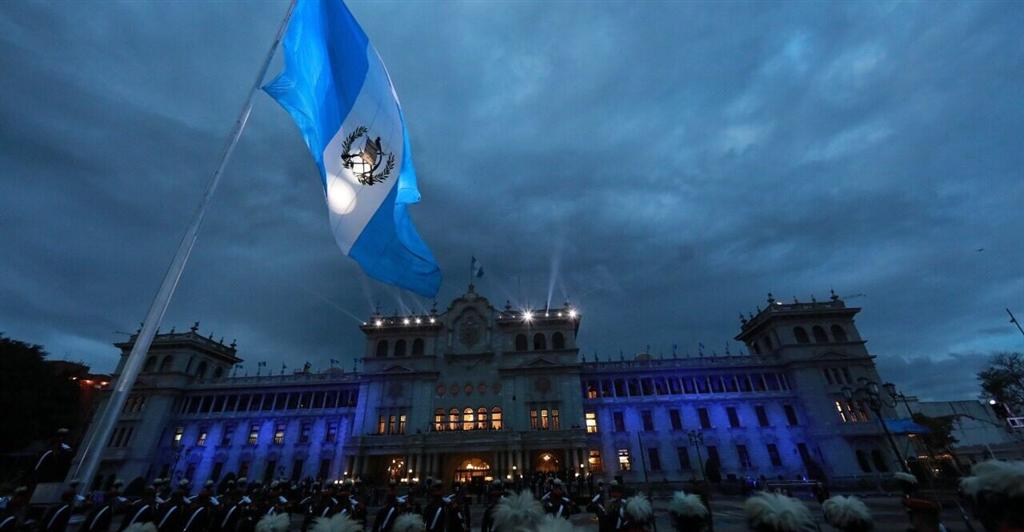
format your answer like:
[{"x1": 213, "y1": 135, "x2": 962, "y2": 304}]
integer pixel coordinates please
[{"x1": 0, "y1": 460, "x2": 1024, "y2": 532}]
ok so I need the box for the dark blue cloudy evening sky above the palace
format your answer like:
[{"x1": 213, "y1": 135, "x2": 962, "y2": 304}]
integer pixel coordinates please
[{"x1": 0, "y1": 1, "x2": 1024, "y2": 398}]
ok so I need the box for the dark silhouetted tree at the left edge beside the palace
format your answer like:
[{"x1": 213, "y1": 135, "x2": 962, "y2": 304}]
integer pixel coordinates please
[{"x1": 0, "y1": 335, "x2": 79, "y2": 452}]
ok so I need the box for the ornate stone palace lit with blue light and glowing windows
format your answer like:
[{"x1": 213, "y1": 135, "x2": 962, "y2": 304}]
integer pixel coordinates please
[{"x1": 73, "y1": 285, "x2": 905, "y2": 482}]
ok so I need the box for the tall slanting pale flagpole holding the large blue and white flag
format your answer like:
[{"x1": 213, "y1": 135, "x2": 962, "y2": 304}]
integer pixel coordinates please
[{"x1": 69, "y1": 0, "x2": 296, "y2": 493}]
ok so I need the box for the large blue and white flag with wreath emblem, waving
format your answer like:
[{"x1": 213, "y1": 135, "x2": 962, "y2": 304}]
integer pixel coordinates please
[{"x1": 263, "y1": 0, "x2": 441, "y2": 297}]
